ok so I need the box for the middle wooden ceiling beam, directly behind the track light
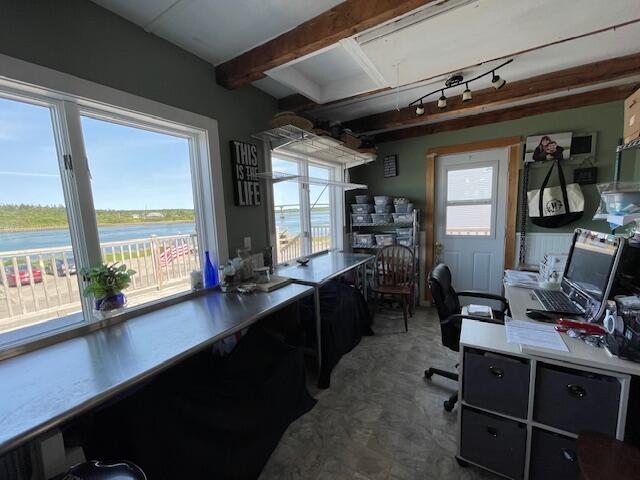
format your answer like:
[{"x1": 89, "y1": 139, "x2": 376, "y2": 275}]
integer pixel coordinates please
[{"x1": 344, "y1": 53, "x2": 640, "y2": 133}]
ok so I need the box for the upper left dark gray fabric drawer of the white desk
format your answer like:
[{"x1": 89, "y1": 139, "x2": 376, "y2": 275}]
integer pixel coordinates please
[{"x1": 462, "y1": 349, "x2": 529, "y2": 418}]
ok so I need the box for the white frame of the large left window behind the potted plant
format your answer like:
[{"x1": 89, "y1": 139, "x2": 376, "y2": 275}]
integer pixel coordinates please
[{"x1": 0, "y1": 54, "x2": 228, "y2": 352}]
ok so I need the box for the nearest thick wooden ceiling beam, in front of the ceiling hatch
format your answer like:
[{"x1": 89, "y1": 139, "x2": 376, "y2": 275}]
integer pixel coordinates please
[{"x1": 216, "y1": 0, "x2": 446, "y2": 89}]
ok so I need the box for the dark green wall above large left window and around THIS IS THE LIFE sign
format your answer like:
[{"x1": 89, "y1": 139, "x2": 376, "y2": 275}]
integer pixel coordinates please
[{"x1": 0, "y1": 0, "x2": 277, "y2": 253}]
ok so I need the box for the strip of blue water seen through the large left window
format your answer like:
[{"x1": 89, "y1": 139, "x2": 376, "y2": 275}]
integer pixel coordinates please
[{"x1": 0, "y1": 223, "x2": 196, "y2": 252}]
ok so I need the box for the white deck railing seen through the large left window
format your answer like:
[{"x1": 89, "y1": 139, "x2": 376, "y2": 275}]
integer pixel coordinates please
[{"x1": 0, "y1": 234, "x2": 200, "y2": 332}]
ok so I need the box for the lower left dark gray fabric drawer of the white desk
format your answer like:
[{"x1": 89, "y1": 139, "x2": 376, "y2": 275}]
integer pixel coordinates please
[{"x1": 460, "y1": 407, "x2": 527, "y2": 479}]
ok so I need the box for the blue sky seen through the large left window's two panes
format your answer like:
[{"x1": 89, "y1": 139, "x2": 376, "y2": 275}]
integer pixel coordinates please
[{"x1": 0, "y1": 99, "x2": 193, "y2": 210}]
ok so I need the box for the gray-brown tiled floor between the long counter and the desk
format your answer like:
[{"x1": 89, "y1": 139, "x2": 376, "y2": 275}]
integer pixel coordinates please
[{"x1": 260, "y1": 309, "x2": 497, "y2": 480}]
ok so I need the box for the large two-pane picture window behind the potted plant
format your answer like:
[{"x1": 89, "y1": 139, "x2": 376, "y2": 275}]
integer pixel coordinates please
[{"x1": 0, "y1": 73, "x2": 226, "y2": 348}]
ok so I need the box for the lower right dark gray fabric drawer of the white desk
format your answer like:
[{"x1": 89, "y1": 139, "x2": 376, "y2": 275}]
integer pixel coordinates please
[{"x1": 529, "y1": 428, "x2": 580, "y2": 480}]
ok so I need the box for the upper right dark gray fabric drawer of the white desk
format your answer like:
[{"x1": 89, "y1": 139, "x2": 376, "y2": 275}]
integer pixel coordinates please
[{"x1": 533, "y1": 364, "x2": 621, "y2": 436}]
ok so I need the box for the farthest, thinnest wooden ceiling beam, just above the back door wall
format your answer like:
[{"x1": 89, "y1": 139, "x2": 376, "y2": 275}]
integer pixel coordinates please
[{"x1": 375, "y1": 83, "x2": 640, "y2": 143}]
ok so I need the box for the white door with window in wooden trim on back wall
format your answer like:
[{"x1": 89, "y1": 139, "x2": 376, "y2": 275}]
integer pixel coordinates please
[{"x1": 434, "y1": 148, "x2": 516, "y2": 294}]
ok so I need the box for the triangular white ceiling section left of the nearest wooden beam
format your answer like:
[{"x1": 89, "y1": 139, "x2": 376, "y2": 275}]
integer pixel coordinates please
[{"x1": 93, "y1": 0, "x2": 342, "y2": 65}]
